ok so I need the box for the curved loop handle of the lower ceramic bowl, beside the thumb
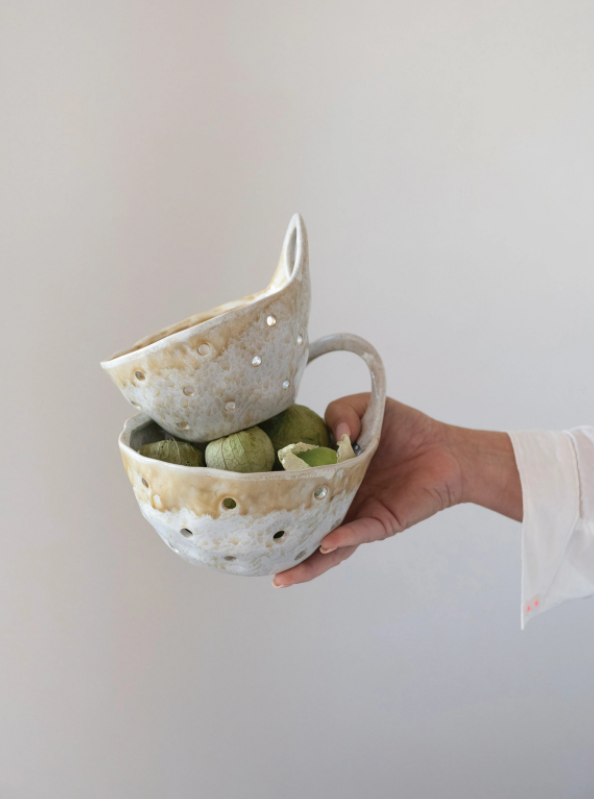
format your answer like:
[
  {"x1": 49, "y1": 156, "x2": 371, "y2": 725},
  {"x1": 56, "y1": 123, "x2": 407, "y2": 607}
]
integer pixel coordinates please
[{"x1": 308, "y1": 333, "x2": 386, "y2": 449}]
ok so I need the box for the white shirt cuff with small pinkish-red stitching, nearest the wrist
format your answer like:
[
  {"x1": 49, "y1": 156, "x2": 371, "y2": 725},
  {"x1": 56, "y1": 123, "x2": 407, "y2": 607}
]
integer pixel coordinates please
[{"x1": 509, "y1": 431, "x2": 580, "y2": 629}]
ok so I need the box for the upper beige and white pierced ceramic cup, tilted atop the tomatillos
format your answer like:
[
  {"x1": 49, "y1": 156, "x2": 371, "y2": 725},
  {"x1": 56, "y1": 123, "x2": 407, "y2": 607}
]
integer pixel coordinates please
[{"x1": 101, "y1": 214, "x2": 310, "y2": 442}]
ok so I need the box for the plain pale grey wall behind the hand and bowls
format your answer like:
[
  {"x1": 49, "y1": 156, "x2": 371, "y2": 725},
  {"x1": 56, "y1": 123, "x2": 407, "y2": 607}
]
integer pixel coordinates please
[{"x1": 0, "y1": 0, "x2": 594, "y2": 799}]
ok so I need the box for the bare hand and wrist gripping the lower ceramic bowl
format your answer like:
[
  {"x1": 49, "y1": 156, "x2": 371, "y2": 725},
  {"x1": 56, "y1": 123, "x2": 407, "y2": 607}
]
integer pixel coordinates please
[{"x1": 273, "y1": 394, "x2": 522, "y2": 588}]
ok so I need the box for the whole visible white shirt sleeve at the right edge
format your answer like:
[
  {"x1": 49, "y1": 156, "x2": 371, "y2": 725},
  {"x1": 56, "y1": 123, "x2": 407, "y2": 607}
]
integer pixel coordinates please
[{"x1": 509, "y1": 427, "x2": 594, "y2": 629}]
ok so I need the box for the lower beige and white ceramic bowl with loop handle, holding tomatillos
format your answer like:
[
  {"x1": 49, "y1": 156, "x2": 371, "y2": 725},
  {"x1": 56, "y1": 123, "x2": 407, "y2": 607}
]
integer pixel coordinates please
[{"x1": 119, "y1": 333, "x2": 386, "y2": 576}]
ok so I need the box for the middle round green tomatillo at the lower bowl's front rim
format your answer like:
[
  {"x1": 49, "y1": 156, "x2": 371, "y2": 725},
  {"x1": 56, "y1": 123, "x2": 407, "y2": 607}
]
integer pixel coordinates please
[{"x1": 204, "y1": 427, "x2": 275, "y2": 472}]
